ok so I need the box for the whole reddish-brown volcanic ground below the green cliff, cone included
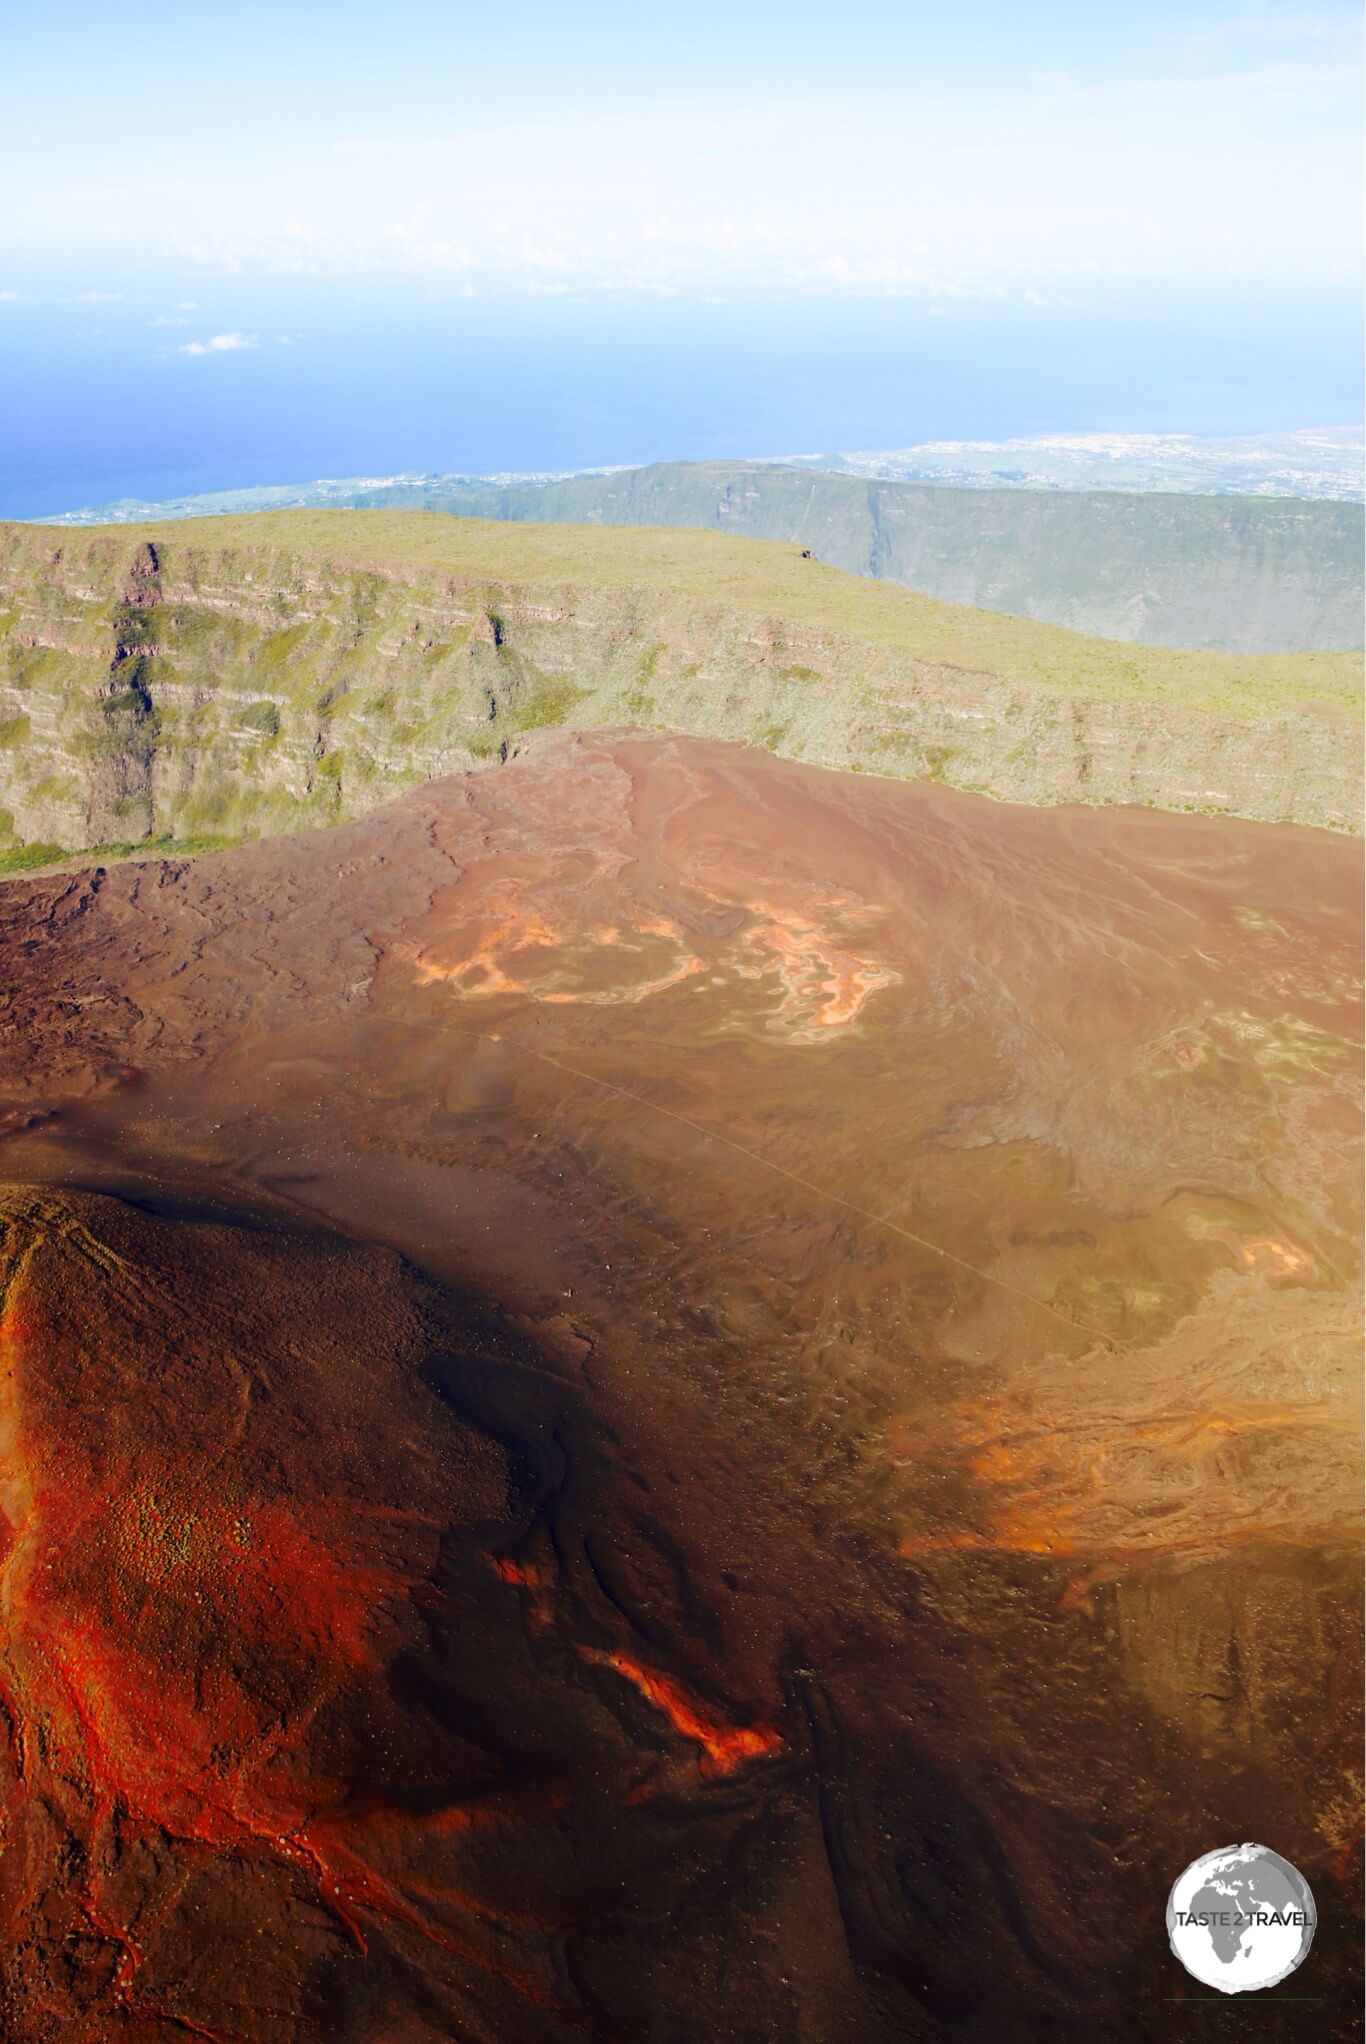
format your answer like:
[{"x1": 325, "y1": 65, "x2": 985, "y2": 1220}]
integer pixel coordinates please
[{"x1": 0, "y1": 736, "x2": 1360, "y2": 2044}]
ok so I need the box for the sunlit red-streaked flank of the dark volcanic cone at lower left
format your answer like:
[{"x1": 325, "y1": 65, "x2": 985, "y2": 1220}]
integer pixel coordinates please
[{"x1": 0, "y1": 1198, "x2": 588, "y2": 2036}]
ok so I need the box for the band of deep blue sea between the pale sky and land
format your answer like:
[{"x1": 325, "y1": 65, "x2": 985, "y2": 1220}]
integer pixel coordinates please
[{"x1": 0, "y1": 278, "x2": 1362, "y2": 517}]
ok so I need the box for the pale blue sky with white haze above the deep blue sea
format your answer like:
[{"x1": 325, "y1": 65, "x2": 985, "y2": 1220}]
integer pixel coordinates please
[{"x1": 0, "y1": 0, "x2": 1362, "y2": 304}]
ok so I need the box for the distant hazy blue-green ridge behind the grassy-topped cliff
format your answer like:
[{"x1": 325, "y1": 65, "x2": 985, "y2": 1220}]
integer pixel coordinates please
[{"x1": 278, "y1": 462, "x2": 1366, "y2": 652}]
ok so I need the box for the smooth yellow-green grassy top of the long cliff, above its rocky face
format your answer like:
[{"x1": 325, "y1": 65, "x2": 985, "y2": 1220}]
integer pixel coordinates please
[{"x1": 72, "y1": 511, "x2": 1362, "y2": 717}]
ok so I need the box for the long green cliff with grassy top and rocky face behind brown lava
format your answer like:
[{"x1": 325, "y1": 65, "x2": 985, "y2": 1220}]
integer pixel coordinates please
[{"x1": 0, "y1": 511, "x2": 1362, "y2": 871}]
